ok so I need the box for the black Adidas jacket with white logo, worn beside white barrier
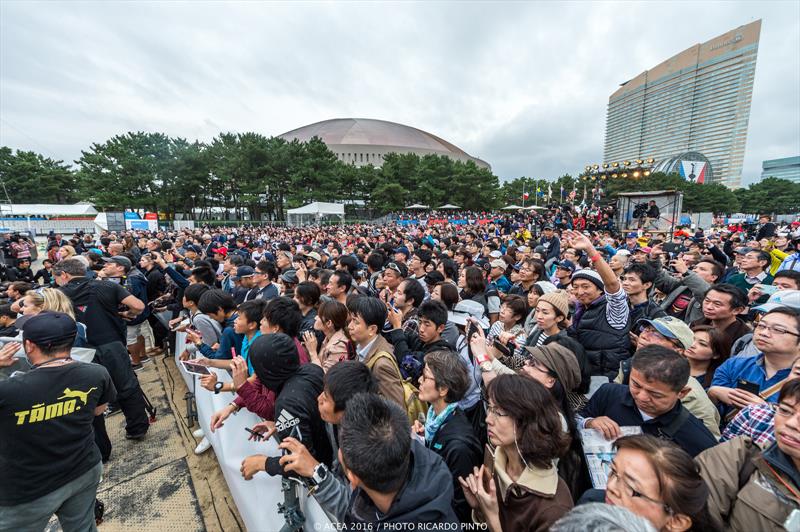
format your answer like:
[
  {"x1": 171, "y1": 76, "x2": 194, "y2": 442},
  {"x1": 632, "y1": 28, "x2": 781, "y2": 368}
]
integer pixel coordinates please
[{"x1": 267, "y1": 364, "x2": 332, "y2": 474}]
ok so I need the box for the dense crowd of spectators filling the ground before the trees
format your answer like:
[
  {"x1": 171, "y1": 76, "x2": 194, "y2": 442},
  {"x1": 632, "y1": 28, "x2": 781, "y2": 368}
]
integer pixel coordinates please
[{"x1": 0, "y1": 209, "x2": 800, "y2": 532}]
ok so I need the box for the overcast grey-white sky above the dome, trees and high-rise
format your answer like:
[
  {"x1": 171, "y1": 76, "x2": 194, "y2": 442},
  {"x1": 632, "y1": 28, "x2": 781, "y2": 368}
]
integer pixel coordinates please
[{"x1": 0, "y1": 0, "x2": 800, "y2": 183}]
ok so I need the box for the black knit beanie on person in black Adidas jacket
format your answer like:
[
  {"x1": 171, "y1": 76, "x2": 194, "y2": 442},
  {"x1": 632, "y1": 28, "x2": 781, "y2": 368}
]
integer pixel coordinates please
[{"x1": 249, "y1": 333, "x2": 300, "y2": 392}]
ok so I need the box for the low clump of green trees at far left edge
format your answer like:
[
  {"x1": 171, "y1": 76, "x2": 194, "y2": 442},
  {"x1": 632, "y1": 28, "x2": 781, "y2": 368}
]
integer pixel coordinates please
[{"x1": 0, "y1": 146, "x2": 77, "y2": 203}]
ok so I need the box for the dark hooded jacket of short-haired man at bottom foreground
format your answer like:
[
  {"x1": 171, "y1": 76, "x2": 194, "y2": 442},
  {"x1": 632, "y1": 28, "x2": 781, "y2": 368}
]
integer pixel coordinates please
[{"x1": 344, "y1": 441, "x2": 459, "y2": 531}]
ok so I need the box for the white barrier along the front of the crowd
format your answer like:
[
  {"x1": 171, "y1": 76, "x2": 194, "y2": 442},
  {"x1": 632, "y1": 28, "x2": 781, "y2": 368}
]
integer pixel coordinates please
[{"x1": 175, "y1": 333, "x2": 334, "y2": 532}]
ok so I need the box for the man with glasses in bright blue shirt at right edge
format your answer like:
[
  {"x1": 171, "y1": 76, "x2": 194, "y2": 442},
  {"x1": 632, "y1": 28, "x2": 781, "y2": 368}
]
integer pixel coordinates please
[{"x1": 708, "y1": 307, "x2": 800, "y2": 412}]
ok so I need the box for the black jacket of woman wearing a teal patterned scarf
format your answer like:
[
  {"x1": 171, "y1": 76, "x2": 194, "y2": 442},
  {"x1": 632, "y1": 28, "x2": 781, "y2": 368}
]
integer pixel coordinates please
[{"x1": 426, "y1": 408, "x2": 483, "y2": 523}]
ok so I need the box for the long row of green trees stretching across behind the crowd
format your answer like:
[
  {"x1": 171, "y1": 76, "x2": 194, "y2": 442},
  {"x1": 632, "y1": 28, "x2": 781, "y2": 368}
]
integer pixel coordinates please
[{"x1": 0, "y1": 132, "x2": 800, "y2": 220}]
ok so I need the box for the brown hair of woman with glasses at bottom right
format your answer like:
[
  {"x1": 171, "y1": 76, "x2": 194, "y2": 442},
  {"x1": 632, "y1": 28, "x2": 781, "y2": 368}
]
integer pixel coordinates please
[{"x1": 614, "y1": 434, "x2": 721, "y2": 531}]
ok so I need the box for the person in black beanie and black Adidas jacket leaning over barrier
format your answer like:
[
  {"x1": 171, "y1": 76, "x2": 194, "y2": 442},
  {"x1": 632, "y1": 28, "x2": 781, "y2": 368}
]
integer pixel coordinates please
[{"x1": 241, "y1": 333, "x2": 331, "y2": 480}]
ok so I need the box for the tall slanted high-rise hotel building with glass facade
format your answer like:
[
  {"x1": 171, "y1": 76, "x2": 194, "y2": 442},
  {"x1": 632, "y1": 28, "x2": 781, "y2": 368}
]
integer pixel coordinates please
[{"x1": 604, "y1": 20, "x2": 761, "y2": 188}]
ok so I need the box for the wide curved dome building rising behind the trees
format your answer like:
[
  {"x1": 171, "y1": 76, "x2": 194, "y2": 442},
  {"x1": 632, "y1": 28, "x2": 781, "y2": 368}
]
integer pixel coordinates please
[{"x1": 279, "y1": 118, "x2": 491, "y2": 169}]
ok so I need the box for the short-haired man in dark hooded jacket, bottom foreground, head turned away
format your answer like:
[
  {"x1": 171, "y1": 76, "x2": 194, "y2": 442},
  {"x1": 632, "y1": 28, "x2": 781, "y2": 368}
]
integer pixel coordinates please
[{"x1": 339, "y1": 394, "x2": 459, "y2": 531}]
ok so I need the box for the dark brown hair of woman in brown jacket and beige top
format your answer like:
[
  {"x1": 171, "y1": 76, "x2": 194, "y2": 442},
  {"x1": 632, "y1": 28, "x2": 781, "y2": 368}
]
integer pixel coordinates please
[{"x1": 486, "y1": 375, "x2": 570, "y2": 469}]
